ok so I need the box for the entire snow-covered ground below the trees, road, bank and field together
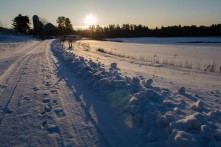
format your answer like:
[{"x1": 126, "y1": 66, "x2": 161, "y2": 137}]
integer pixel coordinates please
[{"x1": 0, "y1": 37, "x2": 221, "y2": 147}]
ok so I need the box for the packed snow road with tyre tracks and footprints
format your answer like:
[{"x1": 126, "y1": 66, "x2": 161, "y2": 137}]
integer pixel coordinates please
[{"x1": 0, "y1": 40, "x2": 142, "y2": 146}]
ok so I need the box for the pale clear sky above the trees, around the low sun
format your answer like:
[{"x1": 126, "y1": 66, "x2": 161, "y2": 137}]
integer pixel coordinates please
[{"x1": 0, "y1": 0, "x2": 221, "y2": 28}]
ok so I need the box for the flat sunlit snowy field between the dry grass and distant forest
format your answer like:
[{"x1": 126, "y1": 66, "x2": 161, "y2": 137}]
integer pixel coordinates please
[{"x1": 77, "y1": 38, "x2": 221, "y2": 71}]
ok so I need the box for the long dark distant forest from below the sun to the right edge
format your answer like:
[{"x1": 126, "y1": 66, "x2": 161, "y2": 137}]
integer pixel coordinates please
[{"x1": 76, "y1": 24, "x2": 221, "y2": 39}]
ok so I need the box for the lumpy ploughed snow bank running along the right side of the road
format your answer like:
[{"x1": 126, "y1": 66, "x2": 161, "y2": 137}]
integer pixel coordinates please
[{"x1": 52, "y1": 40, "x2": 221, "y2": 147}]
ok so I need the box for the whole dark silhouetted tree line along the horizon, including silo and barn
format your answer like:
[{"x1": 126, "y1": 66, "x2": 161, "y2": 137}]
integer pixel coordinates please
[{"x1": 12, "y1": 14, "x2": 221, "y2": 39}]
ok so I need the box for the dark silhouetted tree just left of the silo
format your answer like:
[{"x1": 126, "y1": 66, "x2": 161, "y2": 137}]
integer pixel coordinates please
[{"x1": 12, "y1": 14, "x2": 30, "y2": 33}]
